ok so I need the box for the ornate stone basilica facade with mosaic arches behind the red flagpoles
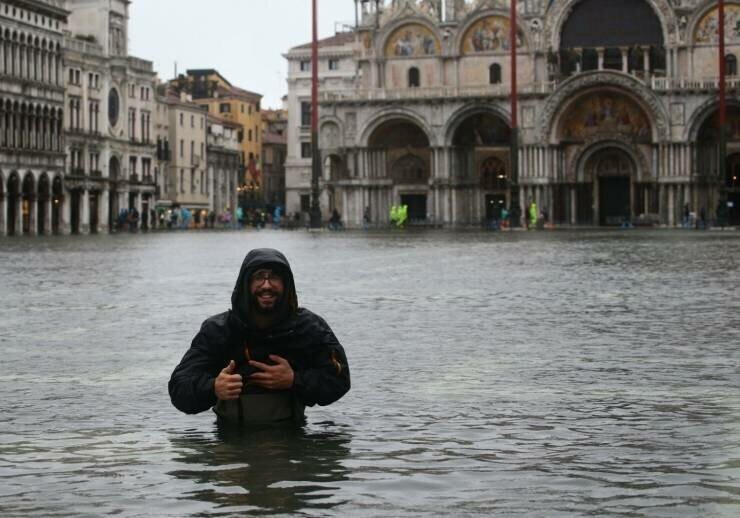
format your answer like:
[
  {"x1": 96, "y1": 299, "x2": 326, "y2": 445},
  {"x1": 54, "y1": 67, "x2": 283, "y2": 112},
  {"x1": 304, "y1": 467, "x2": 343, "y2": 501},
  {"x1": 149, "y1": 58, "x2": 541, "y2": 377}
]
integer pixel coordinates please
[{"x1": 287, "y1": 0, "x2": 740, "y2": 226}]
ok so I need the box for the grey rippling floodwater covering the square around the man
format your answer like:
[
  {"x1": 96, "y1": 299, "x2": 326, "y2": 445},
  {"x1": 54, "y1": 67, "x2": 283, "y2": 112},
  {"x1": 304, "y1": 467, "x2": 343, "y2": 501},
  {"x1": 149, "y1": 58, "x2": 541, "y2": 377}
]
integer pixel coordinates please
[{"x1": 0, "y1": 230, "x2": 740, "y2": 517}]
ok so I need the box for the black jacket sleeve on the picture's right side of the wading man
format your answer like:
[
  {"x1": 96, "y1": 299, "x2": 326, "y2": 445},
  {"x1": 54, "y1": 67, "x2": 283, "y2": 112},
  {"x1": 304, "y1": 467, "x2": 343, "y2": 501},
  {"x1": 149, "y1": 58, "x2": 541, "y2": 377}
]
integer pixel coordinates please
[{"x1": 293, "y1": 320, "x2": 350, "y2": 406}]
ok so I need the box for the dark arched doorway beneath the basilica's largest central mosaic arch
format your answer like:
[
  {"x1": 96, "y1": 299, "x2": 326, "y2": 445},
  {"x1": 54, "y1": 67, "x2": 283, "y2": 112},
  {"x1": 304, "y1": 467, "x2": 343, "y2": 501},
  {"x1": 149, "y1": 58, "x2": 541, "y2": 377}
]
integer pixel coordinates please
[{"x1": 585, "y1": 147, "x2": 637, "y2": 226}]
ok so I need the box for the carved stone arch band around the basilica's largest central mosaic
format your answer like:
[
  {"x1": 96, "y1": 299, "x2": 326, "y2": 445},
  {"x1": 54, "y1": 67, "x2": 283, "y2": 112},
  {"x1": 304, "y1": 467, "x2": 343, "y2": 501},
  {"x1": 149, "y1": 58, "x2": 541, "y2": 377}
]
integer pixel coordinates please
[{"x1": 540, "y1": 71, "x2": 669, "y2": 144}]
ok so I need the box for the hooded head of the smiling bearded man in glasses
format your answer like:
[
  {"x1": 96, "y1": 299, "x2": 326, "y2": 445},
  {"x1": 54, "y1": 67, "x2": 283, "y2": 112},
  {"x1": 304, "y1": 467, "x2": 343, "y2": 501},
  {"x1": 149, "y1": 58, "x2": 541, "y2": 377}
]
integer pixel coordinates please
[{"x1": 231, "y1": 248, "x2": 298, "y2": 323}]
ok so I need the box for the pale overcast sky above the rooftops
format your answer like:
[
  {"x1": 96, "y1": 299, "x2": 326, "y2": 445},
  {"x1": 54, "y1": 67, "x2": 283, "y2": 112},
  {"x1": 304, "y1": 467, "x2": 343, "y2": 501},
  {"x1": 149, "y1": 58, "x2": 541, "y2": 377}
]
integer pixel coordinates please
[{"x1": 129, "y1": 0, "x2": 355, "y2": 108}]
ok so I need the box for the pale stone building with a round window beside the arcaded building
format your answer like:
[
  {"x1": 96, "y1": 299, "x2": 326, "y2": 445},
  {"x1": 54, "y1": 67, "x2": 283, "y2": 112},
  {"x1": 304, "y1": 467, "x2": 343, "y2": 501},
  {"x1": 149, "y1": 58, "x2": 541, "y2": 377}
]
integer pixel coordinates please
[{"x1": 64, "y1": 0, "x2": 157, "y2": 233}]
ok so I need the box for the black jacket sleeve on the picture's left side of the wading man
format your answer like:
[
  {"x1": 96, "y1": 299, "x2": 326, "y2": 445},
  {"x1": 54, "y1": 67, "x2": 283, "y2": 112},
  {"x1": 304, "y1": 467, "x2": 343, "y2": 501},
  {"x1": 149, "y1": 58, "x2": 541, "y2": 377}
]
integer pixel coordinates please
[{"x1": 169, "y1": 321, "x2": 226, "y2": 414}]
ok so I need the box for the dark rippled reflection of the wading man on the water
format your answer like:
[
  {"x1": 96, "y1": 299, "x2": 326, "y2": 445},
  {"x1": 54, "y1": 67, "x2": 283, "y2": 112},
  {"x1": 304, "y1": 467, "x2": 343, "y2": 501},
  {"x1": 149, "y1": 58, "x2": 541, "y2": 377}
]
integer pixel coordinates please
[{"x1": 169, "y1": 425, "x2": 350, "y2": 513}]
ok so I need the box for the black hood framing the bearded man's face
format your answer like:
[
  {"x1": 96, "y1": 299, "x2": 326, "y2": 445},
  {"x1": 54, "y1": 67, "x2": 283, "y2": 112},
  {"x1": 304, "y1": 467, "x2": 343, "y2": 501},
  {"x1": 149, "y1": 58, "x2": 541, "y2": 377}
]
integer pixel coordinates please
[{"x1": 231, "y1": 248, "x2": 298, "y2": 325}]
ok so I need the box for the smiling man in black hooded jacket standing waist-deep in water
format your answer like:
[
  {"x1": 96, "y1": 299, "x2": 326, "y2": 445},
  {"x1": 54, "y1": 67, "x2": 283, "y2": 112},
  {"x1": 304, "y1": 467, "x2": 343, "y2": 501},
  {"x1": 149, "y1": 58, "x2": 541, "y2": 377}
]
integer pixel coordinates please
[{"x1": 169, "y1": 248, "x2": 350, "y2": 424}]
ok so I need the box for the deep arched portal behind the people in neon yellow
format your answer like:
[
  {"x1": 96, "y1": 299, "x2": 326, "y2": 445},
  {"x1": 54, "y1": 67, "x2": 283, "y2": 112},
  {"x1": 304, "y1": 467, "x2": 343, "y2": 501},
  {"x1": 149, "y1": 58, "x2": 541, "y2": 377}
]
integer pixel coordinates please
[{"x1": 368, "y1": 119, "x2": 432, "y2": 224}]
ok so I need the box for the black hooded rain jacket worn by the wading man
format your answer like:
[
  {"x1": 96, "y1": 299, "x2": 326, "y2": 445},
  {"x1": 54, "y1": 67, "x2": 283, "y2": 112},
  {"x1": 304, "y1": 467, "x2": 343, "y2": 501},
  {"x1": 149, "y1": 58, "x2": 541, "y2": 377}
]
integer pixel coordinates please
[{"x1": 169, "y1": 249, "x2": 350, "y2": 420}]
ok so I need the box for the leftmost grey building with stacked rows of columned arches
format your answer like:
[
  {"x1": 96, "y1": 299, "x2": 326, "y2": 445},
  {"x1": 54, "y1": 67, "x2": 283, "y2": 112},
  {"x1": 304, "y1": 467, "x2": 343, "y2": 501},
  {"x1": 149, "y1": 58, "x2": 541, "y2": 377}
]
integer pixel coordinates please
[{"x1": 0, "y1": 0, "x2": 69, "y2": 236}]
